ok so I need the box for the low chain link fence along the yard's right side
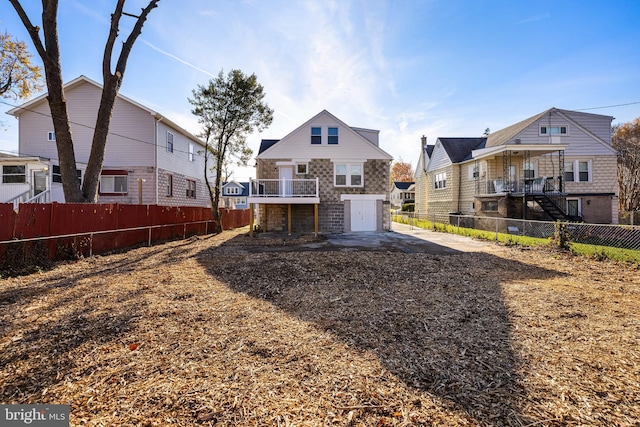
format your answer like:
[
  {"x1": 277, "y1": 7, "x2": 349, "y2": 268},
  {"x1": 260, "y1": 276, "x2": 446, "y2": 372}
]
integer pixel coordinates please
[{"x1": 400, "y1": 212, "x2": 640, "y2": 250}]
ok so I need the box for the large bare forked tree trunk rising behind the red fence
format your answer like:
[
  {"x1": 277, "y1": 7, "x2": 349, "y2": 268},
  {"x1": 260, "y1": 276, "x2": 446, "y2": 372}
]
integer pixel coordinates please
[{"x1": 9, "y1": 0, "x2": 160, "y2": 203}]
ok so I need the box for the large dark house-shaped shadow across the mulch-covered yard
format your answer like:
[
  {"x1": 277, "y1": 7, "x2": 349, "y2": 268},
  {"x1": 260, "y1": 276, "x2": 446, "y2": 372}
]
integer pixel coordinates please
[{"x1": 198, "y1": 236, "x2": 558, "y2": 425}]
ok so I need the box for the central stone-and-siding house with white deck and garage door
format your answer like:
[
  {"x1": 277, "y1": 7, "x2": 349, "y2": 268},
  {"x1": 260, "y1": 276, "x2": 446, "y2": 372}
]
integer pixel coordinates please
[{"x1": 249, "y1": 110, "x2": 392, "y2": 233}]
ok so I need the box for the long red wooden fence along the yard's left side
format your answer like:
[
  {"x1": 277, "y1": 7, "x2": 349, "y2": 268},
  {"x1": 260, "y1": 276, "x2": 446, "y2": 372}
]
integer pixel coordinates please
[{"x1": 0, "y1": 203, "x2": 249, "y2": 270}]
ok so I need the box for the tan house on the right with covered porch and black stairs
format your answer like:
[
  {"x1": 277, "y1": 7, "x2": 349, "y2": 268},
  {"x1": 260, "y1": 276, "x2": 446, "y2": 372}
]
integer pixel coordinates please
[{"x1": 416, "y1": 108, "x2": 618, "y2": 223}]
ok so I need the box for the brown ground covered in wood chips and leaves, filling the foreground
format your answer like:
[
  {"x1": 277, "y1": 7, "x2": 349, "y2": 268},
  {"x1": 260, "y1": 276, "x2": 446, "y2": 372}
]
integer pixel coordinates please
[{"x1": 0, "y1": 229, "x2": 640, "y2": 427}]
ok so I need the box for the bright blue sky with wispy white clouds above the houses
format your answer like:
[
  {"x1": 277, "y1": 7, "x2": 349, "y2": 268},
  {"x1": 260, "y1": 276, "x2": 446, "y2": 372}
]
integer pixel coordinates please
[{"x1": 0, "y1": 0, "x2": 640, "y2": 180}]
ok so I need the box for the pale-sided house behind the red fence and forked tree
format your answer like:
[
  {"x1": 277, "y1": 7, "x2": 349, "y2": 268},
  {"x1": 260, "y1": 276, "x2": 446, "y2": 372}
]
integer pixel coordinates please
[{"x1": 5, "y1": 76, "x2": 210, "y2": 206}]
